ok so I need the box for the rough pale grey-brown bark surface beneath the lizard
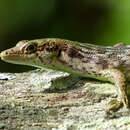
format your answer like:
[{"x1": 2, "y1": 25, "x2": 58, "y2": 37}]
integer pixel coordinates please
[{"x1": 0, "y1": 70, "x2": 130, "y2": 130}]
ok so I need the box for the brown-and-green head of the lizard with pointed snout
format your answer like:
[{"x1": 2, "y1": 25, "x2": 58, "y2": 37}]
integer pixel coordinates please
[{"x1": 0, "y1": 38, "x2": 67, "y2": 68}]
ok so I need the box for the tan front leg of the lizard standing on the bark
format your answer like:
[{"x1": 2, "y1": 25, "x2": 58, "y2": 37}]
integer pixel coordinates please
[{"x1": 100, "y1": 69, "x2": 128, "y2": 110}]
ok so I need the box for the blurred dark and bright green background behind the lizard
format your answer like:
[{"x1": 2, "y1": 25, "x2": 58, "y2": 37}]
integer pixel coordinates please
[{"x1": 0, "y1": 0, "x2": 130, "y2": 72}]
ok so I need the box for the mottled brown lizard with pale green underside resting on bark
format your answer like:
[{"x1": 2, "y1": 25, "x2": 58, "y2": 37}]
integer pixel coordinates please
[{"x1": 0, "y1": 38, "x2": 130, "y2": 110}]
